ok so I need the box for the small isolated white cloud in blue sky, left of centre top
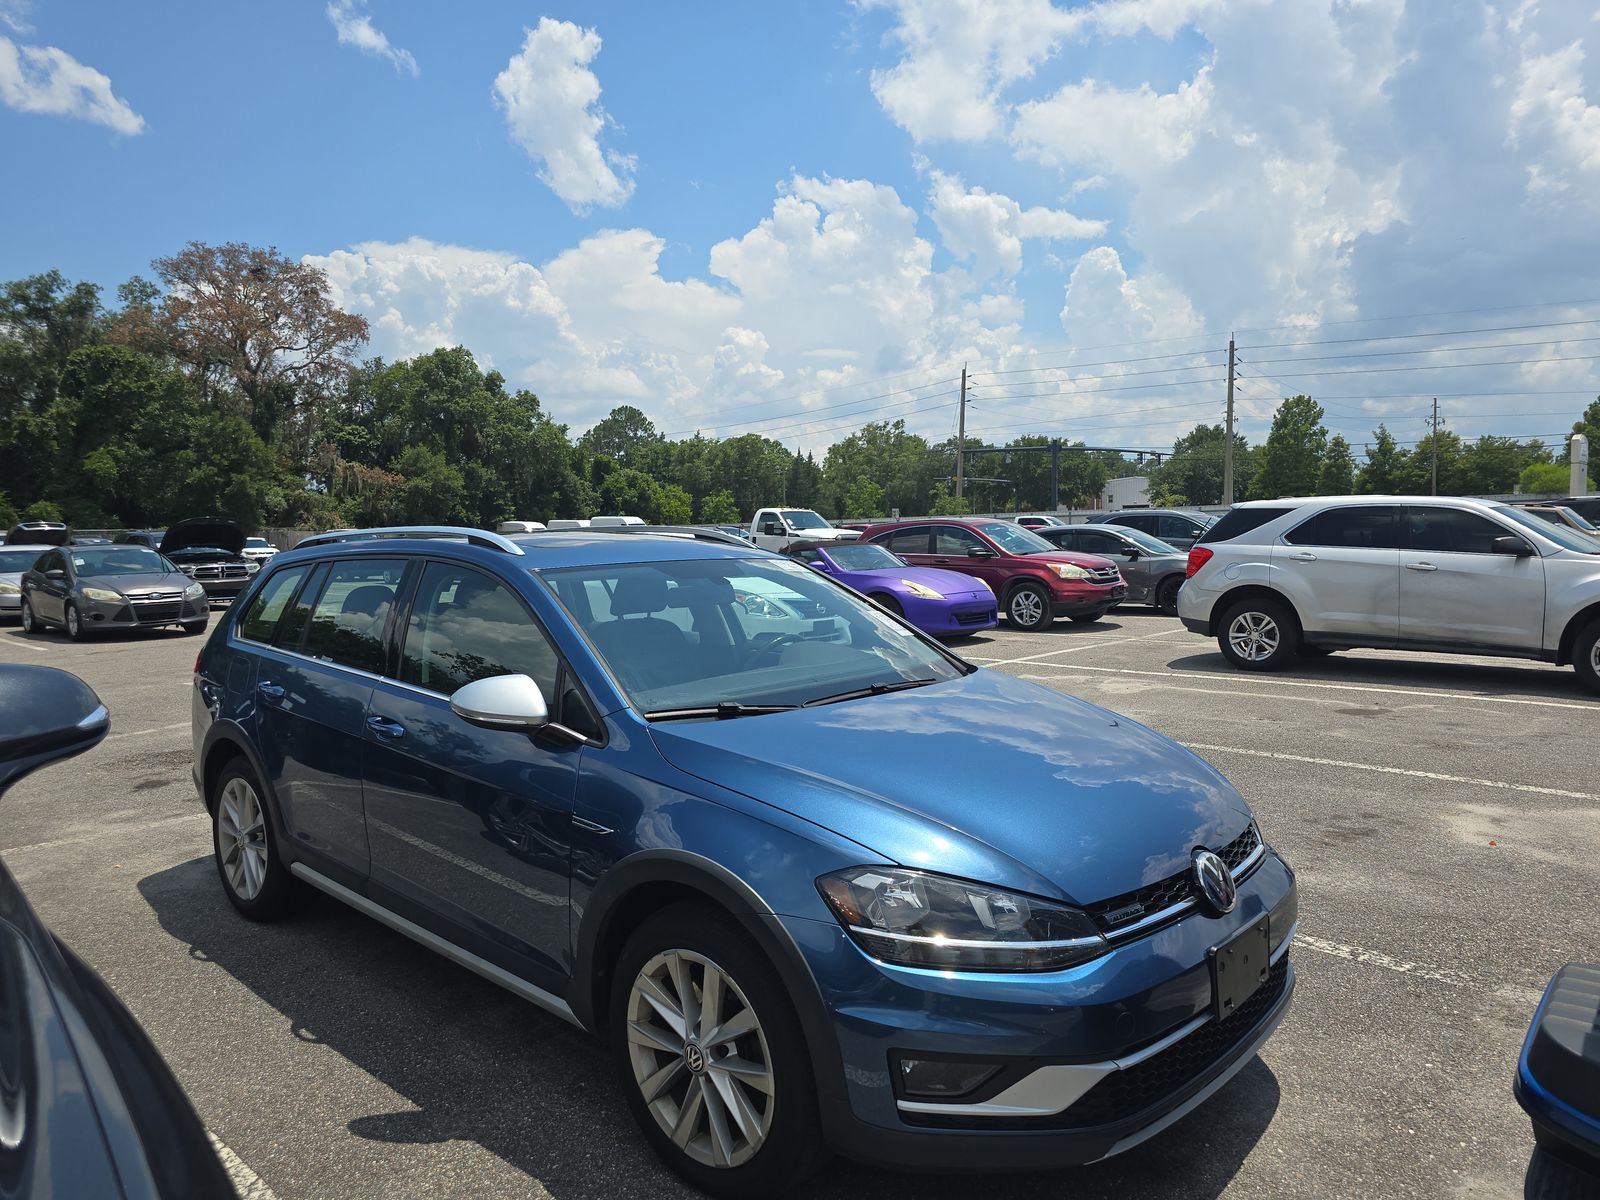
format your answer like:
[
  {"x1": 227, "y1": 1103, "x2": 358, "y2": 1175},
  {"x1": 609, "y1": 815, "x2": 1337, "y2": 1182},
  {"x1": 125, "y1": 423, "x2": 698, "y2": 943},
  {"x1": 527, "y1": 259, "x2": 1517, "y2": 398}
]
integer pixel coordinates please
[{"x1": 494, "y1": 16, "x2": 635, "y2": 213}]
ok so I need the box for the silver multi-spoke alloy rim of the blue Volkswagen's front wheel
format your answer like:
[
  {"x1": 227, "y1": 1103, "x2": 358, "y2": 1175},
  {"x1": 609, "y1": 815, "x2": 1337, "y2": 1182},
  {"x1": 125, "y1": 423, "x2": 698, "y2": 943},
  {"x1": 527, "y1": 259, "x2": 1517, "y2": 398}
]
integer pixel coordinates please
[{"x1": 627, "y1": 950, "x2": 776, "y2": 1168}]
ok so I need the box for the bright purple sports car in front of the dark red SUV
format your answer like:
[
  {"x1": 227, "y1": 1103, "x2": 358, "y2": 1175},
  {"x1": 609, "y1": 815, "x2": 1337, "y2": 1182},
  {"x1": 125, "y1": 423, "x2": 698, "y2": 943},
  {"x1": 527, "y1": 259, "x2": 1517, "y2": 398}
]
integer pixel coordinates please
[{"x1": 784, "y1": 542, "x2": 995, "y2": 637}]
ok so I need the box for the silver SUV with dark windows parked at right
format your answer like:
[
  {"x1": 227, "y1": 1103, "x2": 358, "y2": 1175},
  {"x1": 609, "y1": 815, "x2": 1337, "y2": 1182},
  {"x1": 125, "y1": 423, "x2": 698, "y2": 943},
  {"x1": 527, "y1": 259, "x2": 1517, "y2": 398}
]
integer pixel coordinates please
[{"x1": 1178, "y1": 496, "x2": 1600, "y2": 693}]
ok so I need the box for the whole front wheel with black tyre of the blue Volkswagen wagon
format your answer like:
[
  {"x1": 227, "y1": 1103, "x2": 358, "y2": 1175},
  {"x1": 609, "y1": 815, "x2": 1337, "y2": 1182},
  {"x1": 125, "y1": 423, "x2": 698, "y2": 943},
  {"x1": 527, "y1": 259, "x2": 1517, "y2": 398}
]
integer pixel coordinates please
[{"x1": 608, "y1": 902, "x2": 829, "y2": 1197}]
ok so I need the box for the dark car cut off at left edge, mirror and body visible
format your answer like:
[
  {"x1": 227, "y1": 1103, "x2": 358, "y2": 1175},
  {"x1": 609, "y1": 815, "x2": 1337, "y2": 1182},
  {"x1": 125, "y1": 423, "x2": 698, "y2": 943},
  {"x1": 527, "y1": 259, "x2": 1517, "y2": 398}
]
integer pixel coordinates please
[{"x1": 0, "y1": 664, "x2": 235, "y2": 1200}]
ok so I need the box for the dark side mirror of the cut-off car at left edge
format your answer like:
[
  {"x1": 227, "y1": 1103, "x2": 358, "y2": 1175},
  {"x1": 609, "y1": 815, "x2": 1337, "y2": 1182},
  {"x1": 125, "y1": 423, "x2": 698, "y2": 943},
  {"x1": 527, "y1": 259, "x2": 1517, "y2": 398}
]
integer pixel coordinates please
[{"x1": 0, "y1": 662, "x2": 110, "y2": 792}]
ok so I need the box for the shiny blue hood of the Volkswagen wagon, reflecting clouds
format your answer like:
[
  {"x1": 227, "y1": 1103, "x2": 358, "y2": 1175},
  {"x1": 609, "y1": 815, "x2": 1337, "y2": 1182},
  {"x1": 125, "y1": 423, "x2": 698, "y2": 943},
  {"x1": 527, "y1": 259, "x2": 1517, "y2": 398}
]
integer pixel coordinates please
[{"x1": 651, "y1": 670, "x2": 1250, "y2": 904}]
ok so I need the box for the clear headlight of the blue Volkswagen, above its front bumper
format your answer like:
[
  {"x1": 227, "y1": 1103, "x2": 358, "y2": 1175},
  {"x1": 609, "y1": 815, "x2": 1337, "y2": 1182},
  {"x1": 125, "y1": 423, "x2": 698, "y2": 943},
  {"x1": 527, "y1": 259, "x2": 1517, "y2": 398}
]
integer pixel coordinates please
[{"x1": 816, "y1": 867, "x2": 1109, "y2": 971}]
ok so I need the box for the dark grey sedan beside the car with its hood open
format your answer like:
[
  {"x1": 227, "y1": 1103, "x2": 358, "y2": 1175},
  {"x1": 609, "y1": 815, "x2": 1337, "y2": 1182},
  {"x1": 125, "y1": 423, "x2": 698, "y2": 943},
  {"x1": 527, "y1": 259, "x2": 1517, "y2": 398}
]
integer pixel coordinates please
[{"x1": 21, "y1": 544, "x2": 211, "y2": 642}]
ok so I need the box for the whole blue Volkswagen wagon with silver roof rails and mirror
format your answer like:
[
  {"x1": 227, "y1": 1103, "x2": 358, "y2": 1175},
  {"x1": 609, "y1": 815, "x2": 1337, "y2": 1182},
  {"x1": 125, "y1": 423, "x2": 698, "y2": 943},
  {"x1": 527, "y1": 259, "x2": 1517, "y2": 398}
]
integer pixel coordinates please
[{"x1": 194, "y1": 528, "x2": 1296, "y2": 1195}]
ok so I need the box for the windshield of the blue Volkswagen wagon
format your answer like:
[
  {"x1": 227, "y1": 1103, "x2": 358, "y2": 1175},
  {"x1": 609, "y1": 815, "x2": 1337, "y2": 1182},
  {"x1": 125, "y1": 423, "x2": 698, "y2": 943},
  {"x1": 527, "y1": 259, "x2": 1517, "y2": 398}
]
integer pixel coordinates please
[{"x1": 544, "y1": 558, "x2": 968, "y2": 717}]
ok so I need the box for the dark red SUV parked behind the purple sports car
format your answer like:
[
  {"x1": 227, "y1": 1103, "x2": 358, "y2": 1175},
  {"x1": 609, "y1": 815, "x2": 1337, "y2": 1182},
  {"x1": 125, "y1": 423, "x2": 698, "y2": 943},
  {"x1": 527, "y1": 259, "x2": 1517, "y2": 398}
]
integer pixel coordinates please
[{"x1": 861, "y1": 517, "x2": 1128, "y2": 630}]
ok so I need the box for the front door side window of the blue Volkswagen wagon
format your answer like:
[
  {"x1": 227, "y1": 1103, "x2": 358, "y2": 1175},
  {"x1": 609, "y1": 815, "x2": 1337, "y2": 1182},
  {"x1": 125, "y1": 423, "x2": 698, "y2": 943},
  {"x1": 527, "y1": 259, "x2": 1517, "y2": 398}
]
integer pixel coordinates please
[{"x1": 400, "y1": 563, "x2": 558, "y2": 712}]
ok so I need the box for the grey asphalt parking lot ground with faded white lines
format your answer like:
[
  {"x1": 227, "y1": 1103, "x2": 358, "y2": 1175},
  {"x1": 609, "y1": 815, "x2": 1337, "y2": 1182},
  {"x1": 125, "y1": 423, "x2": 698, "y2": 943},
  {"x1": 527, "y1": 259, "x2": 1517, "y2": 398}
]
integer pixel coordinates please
[{"x1": 0, "y1": 610, "x2": 1600, "y2": 1200}]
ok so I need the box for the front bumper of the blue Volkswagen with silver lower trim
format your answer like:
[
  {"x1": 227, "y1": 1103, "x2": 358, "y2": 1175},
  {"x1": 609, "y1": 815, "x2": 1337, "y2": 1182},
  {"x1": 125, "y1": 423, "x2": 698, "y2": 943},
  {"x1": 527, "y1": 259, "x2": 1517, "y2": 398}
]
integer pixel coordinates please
[{"x1": 786, "y1": 853, "x2": 1296, "y2": 1170}]
